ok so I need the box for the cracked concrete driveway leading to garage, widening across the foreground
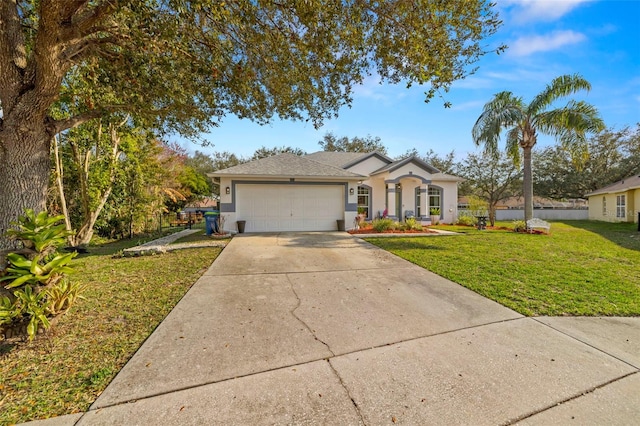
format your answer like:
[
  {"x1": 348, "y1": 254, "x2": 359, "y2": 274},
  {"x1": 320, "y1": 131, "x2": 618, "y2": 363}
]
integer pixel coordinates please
[{"x1": 52, "y1": 232, "x2": 640, "y2": 425}]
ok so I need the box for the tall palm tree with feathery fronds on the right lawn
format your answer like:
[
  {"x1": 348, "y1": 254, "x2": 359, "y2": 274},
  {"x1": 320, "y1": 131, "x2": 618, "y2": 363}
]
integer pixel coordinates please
[{"x1": 471, "y1": 74, "x2": 605, "y2": 221}]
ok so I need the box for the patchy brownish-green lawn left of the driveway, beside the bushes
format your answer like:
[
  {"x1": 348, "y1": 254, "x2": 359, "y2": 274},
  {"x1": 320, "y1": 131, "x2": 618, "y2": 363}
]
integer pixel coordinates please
[{"x1": 0, "y1": 235, "x2": 221, "y2": 424}]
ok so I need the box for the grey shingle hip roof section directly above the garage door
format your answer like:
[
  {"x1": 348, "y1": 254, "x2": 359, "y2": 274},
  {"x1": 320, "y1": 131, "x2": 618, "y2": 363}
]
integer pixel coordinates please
[{"x1": 209, "y1": 153, "x2": 365, "y2": 178}]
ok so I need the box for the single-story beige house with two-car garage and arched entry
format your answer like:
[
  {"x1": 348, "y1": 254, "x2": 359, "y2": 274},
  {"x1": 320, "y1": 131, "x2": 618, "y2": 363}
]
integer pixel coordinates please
[{"x1": 209, "y1": 151, "x2": 463, "y2": 232}]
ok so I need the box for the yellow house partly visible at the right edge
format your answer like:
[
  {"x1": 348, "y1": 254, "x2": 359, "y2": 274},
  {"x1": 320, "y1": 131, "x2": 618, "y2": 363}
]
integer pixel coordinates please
[{"x1": 586, "y1": 175, "x2": 640, "y2": 222}]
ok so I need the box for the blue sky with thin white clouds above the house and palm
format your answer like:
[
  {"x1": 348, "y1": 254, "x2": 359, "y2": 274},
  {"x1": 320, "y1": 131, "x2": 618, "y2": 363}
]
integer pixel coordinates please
[{"x1": 184, "y1": 0, "x2": 640, "y2": 159}]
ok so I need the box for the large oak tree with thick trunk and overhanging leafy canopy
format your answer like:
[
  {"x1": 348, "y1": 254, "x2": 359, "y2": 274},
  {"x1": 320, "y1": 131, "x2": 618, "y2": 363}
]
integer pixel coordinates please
[{"x1": 0, "y1": 0, "x2": 500, "y2": 250}]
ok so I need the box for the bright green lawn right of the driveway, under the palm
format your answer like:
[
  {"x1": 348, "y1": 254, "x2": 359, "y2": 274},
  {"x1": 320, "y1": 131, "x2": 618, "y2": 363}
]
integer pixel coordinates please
[{"x1": 367, "y1": 221, "x2": 640, "y2": 316}]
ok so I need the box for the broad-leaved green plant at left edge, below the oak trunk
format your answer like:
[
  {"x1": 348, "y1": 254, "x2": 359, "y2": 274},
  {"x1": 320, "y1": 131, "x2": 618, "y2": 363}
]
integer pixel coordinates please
[{"x1": 0, "y1": 210, "x2": 82, "y2": 339}]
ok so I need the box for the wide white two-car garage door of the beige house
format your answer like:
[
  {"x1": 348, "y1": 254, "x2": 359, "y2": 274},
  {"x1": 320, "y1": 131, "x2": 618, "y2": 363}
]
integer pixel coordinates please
[{"x1": 236, "y1": 184, "x2": 344, "y2": 232}]
